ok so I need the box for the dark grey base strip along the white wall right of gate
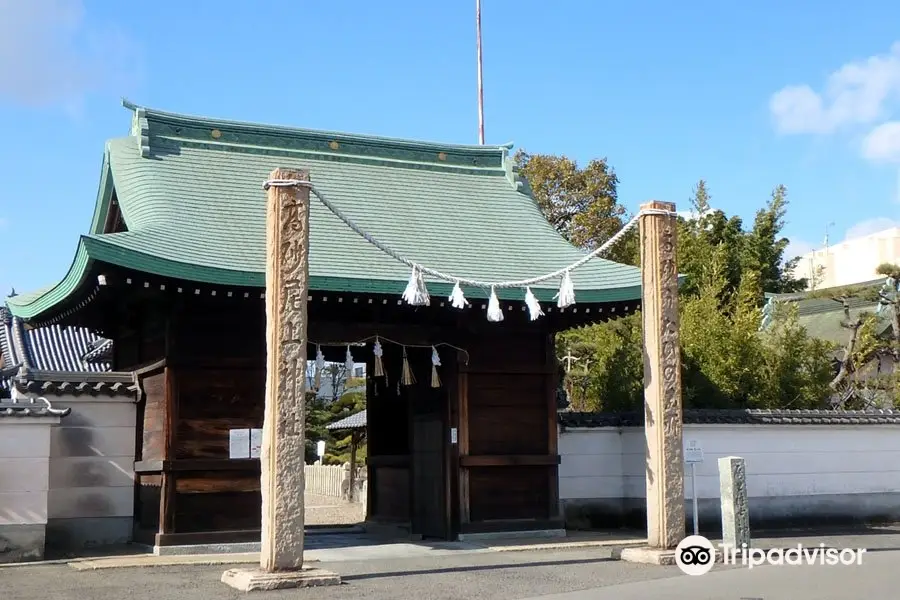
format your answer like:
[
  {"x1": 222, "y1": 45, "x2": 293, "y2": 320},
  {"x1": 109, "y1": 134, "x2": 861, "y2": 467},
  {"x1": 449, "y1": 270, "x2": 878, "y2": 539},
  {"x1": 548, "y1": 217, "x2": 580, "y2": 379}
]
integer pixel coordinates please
[{"x1": 560, "y1": 493, "x2": 900, "y2": 535}]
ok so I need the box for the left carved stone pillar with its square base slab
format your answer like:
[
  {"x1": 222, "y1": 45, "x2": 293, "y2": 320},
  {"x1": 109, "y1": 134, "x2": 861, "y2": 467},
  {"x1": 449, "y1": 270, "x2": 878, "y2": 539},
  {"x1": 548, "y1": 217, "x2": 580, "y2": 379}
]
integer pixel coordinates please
[{"x1": 222, "y1": 169, "x2": 341, "y2": 591}]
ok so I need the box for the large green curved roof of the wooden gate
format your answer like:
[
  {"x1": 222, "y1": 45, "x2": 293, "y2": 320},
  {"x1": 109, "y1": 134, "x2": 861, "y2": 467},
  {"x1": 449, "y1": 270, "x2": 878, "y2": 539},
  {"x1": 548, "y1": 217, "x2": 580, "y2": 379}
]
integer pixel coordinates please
[{"x1": 9, "y1": 104, "x2": 640, "y2": 318}]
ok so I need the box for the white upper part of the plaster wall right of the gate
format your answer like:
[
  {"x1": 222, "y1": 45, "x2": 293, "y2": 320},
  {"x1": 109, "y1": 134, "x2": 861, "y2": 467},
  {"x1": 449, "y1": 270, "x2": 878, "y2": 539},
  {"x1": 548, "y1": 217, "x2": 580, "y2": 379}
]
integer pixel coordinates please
[{"x1": 559, "y1": 425, "x2": 900, "y2": 500}]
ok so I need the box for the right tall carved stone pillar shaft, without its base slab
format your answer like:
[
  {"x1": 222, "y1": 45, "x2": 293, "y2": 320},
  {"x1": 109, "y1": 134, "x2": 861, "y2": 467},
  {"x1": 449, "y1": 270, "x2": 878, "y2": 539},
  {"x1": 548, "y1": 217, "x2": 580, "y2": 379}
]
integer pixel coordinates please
[{"x1": 639, "y1": 202, "x2": 685, "y2": 549}]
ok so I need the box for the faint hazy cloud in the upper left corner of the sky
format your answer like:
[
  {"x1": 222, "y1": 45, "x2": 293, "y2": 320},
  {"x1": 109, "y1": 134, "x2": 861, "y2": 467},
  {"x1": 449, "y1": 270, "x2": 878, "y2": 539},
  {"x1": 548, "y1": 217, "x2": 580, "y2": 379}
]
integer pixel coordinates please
[{"x1": 0, "y1": 0, "x2": 135, "y2": 108}]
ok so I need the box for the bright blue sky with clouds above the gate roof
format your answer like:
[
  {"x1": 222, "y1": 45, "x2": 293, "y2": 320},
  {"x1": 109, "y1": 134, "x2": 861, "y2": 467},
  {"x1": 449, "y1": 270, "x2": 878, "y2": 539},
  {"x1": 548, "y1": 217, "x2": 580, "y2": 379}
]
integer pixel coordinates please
[{"x1": 0, "y1": 0, "x2": 900, "y2": 294}]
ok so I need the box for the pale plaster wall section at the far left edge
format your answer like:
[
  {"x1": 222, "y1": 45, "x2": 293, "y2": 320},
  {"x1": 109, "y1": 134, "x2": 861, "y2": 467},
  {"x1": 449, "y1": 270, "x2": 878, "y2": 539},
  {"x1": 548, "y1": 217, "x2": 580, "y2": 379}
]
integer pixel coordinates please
[{"x1": 0, "y1": 417, "x2": 59, "y2": 526}]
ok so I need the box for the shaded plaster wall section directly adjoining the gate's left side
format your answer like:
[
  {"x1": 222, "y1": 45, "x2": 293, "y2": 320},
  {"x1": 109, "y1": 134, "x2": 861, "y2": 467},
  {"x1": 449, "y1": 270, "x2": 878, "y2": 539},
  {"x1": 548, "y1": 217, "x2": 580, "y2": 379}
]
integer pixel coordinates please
[{"x1": 48, "y1": 396, "x2": 136, "y2": 521}]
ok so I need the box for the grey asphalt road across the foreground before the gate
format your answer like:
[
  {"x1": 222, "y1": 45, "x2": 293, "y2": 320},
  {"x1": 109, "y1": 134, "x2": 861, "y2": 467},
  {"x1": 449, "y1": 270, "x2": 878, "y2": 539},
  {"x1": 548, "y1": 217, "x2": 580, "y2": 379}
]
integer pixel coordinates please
[{"x1": 0, "y1": 549, "x2": 900, "y2": 600}]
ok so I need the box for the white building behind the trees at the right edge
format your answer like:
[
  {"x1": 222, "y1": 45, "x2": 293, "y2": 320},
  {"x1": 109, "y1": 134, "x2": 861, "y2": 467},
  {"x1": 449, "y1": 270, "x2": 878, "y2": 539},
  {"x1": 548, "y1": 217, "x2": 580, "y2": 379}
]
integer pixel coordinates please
[{"x1": 794, "y1": 227, "x2": 900, "y2": 289}]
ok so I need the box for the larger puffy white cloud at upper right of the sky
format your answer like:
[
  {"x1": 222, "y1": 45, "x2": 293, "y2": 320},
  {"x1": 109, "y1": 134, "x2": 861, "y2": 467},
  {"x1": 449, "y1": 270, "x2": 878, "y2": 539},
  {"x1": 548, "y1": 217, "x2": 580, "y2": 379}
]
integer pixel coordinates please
[{"x1": 769, "y1": 42, "x2": 900, "y2": 134}]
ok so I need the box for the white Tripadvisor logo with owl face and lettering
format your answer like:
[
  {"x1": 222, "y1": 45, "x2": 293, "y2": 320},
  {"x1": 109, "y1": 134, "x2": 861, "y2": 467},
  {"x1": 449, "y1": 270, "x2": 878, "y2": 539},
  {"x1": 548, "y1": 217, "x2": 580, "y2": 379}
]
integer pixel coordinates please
[{"x1": 675, "y1": 535, "x2": 866, "y2": 575}]
